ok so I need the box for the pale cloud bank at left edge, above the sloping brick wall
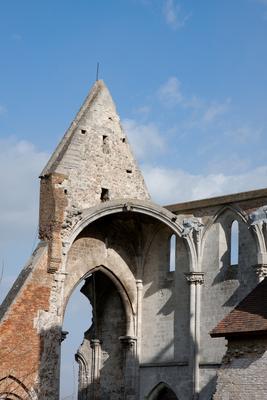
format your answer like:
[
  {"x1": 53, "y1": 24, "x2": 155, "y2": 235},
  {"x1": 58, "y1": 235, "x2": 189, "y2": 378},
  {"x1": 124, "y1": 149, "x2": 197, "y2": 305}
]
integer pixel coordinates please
[{"x1": 0, "y1": 137, "x2": 48, "y2": 301}]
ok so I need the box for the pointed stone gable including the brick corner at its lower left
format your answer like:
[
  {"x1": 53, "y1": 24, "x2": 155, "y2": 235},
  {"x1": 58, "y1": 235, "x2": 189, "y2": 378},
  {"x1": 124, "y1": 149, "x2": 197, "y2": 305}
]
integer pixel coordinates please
[{"x1": 39, "y1": 81, "x2": 150, "y2": 272}]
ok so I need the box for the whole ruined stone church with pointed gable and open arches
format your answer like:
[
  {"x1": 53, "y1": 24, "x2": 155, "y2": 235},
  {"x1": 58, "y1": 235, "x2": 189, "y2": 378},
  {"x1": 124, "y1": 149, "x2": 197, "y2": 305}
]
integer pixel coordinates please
[{"x1": 0, "y1": 81, "x2": 267, "y2": 400}]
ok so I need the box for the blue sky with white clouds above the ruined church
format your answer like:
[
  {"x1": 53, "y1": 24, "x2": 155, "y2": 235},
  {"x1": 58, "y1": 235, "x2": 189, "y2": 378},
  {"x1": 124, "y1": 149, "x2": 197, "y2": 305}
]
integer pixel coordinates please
[{"x1": 0, "y1": 0, "x2": 267, "y2": 396}]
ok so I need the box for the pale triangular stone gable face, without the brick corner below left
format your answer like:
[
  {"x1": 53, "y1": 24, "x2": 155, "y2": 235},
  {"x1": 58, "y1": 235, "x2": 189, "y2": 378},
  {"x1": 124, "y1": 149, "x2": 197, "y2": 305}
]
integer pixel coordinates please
[{"x1": 41, "y1": 77, "x2": 149, "y2": 209}]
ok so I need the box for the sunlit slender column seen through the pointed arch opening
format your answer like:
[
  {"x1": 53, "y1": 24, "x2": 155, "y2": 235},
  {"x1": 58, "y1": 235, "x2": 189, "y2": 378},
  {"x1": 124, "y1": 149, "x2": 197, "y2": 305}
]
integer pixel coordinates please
[{"x1": 90, "y1": 339, "x2": 102, "y2": 400}]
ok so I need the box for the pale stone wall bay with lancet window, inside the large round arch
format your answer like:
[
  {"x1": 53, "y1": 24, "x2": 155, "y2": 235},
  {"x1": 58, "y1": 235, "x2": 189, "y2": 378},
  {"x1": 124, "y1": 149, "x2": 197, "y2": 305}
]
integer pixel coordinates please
[{"x1": 141, "y1": 228, "x2": 190, "y2": 364}]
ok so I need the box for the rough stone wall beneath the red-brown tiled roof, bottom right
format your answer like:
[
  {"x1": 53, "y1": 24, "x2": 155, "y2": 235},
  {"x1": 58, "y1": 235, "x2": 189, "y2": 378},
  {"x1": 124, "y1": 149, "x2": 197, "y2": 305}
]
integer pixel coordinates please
[{"x1": 214, "y1": 338, "x2": 267, "y2": 400}]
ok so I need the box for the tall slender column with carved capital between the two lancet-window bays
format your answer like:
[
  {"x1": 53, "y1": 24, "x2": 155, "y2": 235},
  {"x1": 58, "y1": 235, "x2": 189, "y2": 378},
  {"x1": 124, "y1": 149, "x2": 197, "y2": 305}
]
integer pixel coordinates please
[{"x1": 186, "y1": 272, "x2": 204, "y2": 400}]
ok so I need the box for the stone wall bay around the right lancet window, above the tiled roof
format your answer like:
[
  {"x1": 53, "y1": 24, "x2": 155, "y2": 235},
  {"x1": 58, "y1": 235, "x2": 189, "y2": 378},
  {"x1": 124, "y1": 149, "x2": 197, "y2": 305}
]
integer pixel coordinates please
[{"x1": 201, "y1": 210, "x2": 258, "y2": 363}]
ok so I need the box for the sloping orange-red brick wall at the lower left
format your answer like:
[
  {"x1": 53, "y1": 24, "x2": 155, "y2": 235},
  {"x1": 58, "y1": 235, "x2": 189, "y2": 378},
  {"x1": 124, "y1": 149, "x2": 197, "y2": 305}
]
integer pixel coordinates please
[{"x1": 0, "y1": 248, "x2": 52, "y2": 398}]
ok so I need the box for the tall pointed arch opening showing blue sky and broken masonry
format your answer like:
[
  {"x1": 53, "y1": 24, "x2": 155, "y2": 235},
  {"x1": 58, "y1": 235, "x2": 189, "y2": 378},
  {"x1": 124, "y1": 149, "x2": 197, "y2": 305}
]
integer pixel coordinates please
[{"x1": 60, "y1": 270, "x2": 129, "y2": 400}]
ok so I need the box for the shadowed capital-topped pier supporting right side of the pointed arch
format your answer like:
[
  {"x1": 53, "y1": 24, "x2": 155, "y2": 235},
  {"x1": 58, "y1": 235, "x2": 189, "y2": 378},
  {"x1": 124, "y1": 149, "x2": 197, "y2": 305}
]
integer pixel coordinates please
[{"x1": 120, "y1": 336, "x2": 138, "y2": 400}]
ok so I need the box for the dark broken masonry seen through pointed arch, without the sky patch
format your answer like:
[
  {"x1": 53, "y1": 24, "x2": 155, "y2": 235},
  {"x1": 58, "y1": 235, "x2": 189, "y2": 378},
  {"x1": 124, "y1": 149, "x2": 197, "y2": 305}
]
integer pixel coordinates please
[{"x1": 73, "y1": 268, "x2": 136, "y2": 400}]
